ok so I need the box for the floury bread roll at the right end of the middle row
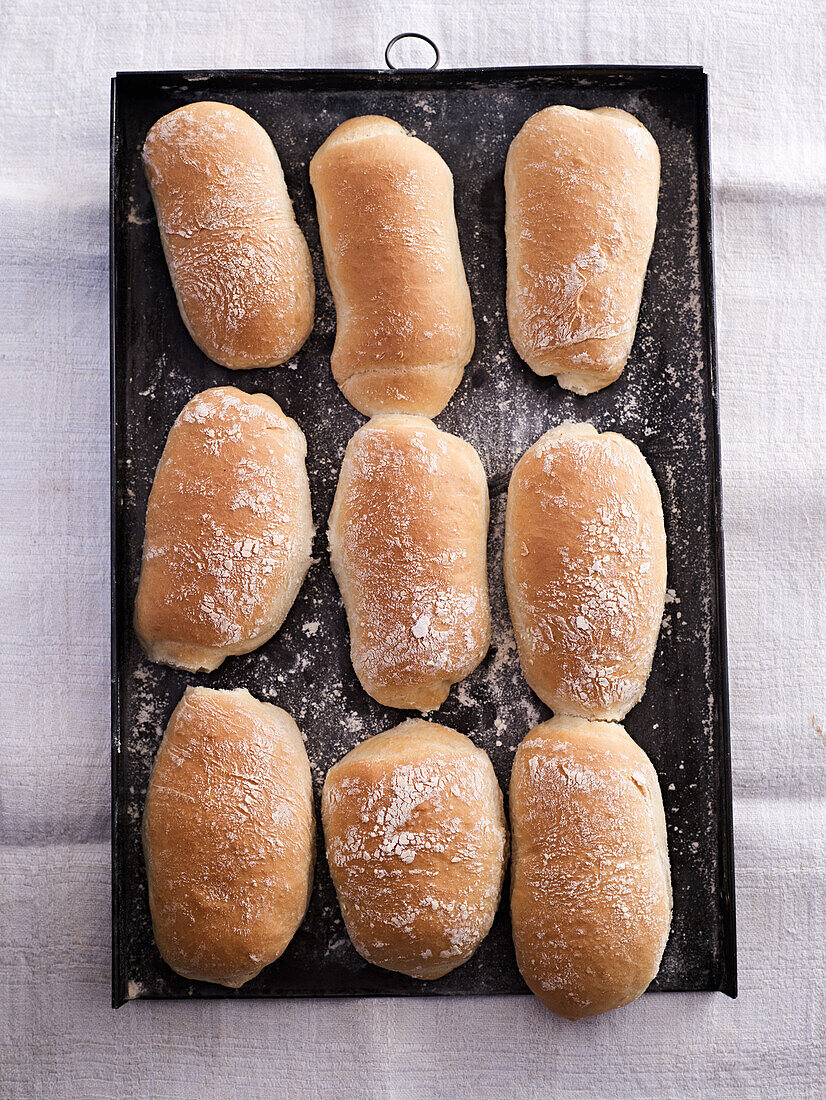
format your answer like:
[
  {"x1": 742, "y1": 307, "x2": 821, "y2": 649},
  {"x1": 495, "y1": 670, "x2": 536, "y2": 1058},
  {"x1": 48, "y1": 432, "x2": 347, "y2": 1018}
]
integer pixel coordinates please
[{"x1": 504, "y1": 424, "x2": 665, "y2": 719}]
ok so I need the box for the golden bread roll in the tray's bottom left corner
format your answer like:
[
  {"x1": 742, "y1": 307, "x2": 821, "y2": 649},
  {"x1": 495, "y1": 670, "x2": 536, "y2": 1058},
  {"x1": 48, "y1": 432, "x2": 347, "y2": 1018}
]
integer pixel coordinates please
[{"x1": 143, "y1": 688, "x2": 316, "y2": 989}]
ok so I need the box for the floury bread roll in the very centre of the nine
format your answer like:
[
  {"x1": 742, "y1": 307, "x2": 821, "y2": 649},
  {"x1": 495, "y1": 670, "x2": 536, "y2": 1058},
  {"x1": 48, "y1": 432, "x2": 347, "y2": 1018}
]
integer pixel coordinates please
[{"x1": 329, "y1": 414, "x2": 491, "y2": 711}]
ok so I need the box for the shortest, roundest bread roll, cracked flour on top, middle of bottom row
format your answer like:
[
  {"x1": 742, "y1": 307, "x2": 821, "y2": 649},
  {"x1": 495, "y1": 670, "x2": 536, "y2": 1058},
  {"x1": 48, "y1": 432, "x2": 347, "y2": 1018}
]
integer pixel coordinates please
[{"x1": 321, "y1": 718, "x2": 508, "y2": 979}]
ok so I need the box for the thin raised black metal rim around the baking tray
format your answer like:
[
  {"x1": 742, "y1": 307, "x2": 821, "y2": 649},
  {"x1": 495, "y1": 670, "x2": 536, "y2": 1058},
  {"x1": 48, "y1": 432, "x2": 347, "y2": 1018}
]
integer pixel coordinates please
[{"x1": 109, "y1": 65, "x2": 738, "y2": 1009}]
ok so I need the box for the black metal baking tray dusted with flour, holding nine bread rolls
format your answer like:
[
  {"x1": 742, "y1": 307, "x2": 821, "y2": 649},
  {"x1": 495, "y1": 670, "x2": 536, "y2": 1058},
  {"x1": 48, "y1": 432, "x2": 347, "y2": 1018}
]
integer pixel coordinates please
[{"x1": 111, "y1": 58, "x2": 736, "y2": 1005}]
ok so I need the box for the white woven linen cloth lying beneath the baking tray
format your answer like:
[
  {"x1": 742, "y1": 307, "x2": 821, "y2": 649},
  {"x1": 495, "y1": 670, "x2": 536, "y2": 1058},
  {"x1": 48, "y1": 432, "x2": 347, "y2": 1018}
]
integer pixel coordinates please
[{"x1": 0, "y1": 0, "x2": 826, "y2": 1100}]
